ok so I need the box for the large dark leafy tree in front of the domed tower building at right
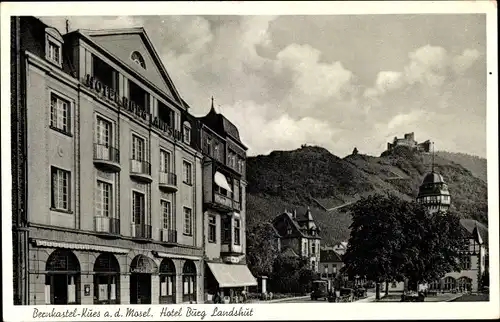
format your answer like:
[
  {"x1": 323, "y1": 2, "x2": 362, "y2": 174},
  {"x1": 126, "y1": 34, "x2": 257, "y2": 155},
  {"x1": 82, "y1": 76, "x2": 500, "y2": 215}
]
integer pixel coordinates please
[{"x1": 344, "y1": 195, "x2": 464, "y2": 299}]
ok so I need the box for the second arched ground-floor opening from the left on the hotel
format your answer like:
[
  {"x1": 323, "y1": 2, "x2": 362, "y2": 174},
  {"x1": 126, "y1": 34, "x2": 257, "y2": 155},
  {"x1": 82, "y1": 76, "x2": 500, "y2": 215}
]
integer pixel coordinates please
[{"x1": 94, "y1": 253, "x2": 120, "y2": 304}]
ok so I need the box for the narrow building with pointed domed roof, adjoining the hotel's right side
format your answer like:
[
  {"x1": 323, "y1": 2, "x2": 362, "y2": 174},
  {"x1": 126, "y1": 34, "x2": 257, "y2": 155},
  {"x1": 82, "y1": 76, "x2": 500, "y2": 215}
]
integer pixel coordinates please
[{"x1": 195, "y1": 97, "x2": 257, "y2": 301}]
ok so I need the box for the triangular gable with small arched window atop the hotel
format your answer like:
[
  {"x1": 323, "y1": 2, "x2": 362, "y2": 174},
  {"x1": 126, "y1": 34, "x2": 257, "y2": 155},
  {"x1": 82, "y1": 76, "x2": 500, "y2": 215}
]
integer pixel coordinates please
[{"x1": 76, "y1": 27, "x2": 186, "y2": 109}]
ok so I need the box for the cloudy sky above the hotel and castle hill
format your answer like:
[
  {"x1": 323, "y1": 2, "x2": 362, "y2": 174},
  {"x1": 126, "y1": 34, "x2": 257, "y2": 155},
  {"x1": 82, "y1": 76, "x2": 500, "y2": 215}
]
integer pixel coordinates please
[{"x1": 40, "y1": 14, "x2": 487, "y2": 157}]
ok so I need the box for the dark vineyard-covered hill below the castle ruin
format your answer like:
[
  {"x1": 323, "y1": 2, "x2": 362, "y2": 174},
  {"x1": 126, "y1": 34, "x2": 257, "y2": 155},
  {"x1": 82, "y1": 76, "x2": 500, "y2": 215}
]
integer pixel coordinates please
[{"x1": 247, "y1": 146, "x2": 487, "y2": 244}]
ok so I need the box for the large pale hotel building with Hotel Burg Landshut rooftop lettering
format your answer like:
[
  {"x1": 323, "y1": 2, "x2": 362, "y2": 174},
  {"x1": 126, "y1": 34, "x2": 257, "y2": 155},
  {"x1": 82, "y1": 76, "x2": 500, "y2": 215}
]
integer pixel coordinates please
[{"x1": 11, "y1": 17, "x2": 254, "y2": 305}]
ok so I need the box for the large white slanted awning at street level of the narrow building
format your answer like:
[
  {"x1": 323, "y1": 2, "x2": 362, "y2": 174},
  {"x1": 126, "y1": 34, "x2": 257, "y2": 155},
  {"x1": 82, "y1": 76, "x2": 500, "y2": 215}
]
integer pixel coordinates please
[{"x1": 207, "y1": 263, "x2": 257, "y2": 287}]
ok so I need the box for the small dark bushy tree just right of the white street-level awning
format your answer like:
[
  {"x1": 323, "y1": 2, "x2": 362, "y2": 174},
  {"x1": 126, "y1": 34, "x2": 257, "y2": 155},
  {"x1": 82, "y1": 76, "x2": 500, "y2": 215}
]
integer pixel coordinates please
[{"x1": 246, "y1": 223, "x2": 278, "y2": 276}]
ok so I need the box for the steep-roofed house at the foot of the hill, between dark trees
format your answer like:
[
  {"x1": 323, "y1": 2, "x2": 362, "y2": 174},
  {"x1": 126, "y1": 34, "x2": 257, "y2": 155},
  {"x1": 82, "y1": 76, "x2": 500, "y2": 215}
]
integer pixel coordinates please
[{"x1": 273, "y1": 207, "x2": 321, "y2": 272}]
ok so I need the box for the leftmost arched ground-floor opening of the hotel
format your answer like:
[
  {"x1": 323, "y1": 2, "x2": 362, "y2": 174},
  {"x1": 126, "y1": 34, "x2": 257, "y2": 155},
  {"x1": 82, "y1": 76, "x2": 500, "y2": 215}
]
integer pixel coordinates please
[{"x1": 45, "y1": 249, "x2": 80, "y2": 305}]
